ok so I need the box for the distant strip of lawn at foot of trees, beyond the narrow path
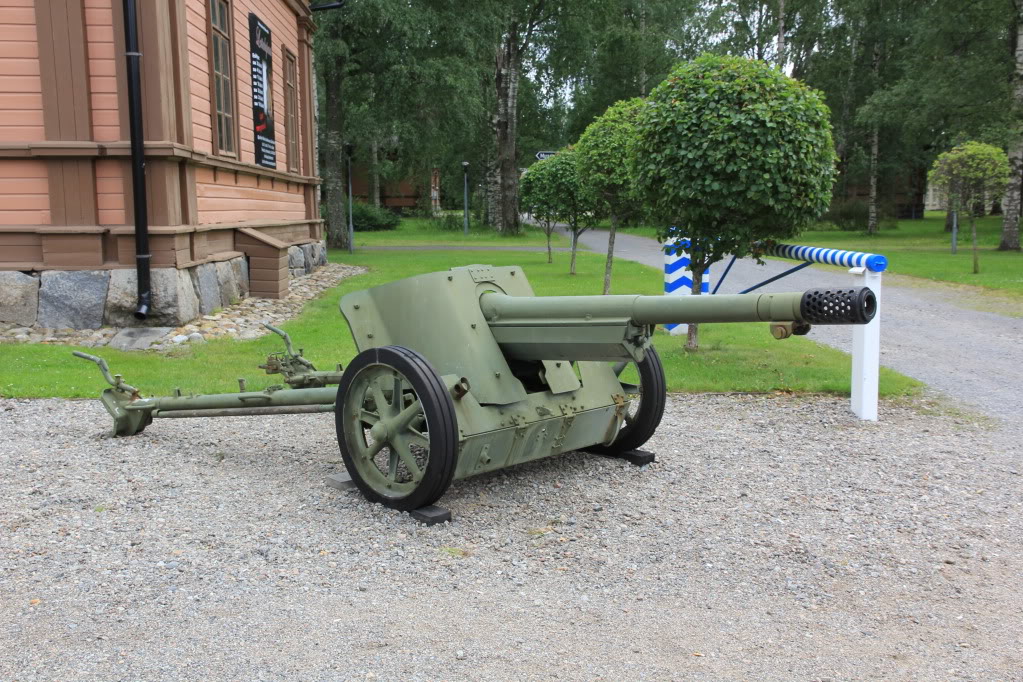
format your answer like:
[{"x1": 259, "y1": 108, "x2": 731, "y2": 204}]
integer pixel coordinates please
[{"x1": 355, "y1": 218, "x2": 569, "y2": 248}]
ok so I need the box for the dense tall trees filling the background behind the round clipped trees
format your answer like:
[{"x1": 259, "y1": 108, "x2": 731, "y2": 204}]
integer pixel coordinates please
[{"x1": 314, "y1": 0, "x2": 1023, "y2": 253}]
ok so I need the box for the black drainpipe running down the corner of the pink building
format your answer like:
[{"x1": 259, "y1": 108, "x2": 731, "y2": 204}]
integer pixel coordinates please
[{"x1": 124, "y1": 0, "x2": 152, "y2": 320}]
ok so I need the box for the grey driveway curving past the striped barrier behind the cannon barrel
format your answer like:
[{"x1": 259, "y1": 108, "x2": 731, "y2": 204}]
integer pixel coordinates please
[{"x1": 580, "y1": 230, "x2": 1023, "y2": 421}]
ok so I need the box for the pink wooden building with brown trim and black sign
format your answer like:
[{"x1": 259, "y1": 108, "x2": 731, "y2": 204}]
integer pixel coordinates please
[{"x1": 0, "y1": 0, "x2": 325, "y2": 326}]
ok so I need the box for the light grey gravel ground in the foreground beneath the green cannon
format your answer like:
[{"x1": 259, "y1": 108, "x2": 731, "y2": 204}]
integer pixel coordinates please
[{"x1": 0, "y1": 396, "x2": 1023, "y2": 681}]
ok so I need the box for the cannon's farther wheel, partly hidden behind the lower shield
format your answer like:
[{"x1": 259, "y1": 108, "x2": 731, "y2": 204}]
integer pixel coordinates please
[{"x1": 587, "y1": 346, "x2": 667, "y2": 455}]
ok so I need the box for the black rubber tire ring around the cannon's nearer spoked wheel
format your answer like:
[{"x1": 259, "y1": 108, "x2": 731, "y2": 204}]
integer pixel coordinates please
[{"x1": 333, "y1": 346, "x2": 458, "y2": 511}]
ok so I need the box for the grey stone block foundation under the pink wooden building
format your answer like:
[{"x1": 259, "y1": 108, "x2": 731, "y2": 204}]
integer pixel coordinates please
[{"x1": 0, "y1": 243, "x2": 326, "y2": 329}]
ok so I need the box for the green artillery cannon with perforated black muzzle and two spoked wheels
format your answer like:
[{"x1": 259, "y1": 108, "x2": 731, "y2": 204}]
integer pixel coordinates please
[{"x1": 76, "y1": 265, "x2": 876, "y2": 510}]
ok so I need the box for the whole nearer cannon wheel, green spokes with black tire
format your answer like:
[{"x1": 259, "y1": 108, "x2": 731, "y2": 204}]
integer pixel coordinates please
[{"x1": 335, "y1": 346, "x2": 458, "y2": 511}]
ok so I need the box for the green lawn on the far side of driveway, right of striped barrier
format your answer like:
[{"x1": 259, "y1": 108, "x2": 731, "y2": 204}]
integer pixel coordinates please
[{"x1": 597, "y1": 211, "x2": 1023, "y2": 295}]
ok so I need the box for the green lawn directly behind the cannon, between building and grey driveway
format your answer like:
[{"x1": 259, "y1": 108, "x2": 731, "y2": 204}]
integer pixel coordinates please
[{"x1": 0, "y1": 251, "x2": 919, "y2": 398}]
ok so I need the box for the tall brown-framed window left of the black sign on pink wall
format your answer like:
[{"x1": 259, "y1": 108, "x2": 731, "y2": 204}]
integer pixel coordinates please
[{"x1": 210, "y1": 0, "x2": 237, "y2": 155}]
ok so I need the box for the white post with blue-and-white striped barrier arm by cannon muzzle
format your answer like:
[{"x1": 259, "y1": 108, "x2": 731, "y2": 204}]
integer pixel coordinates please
[{"x1": 767, "y1": 244, "x2": 888, "y2": 421}]
